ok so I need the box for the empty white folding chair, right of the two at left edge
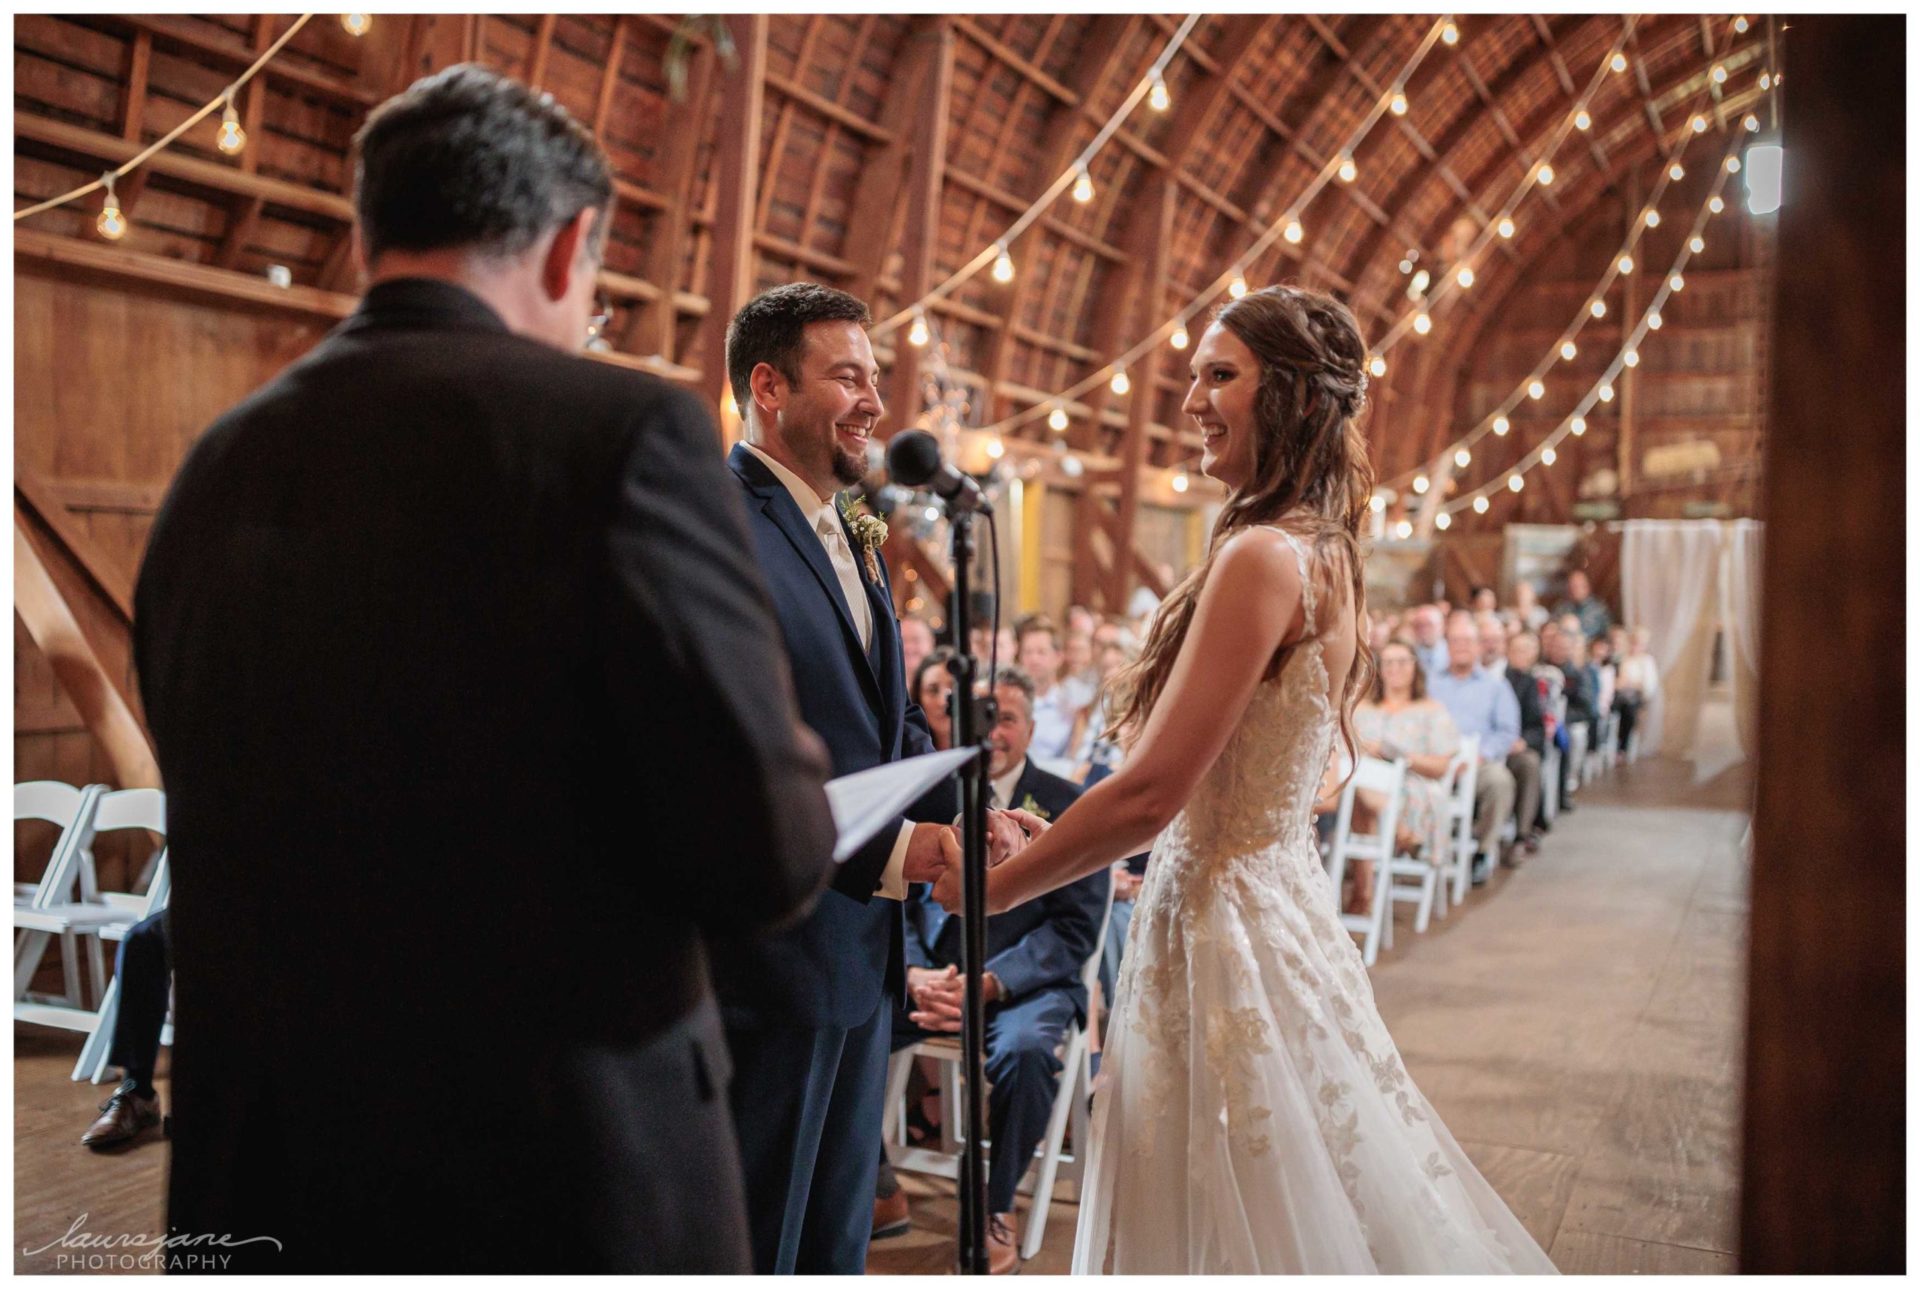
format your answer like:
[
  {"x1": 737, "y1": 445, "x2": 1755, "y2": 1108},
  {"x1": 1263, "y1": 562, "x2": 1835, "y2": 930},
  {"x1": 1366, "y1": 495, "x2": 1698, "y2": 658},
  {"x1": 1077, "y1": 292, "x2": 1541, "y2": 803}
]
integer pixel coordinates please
[{"x1": 13, "y1": 788, "x2": 167, "y2": 1034}]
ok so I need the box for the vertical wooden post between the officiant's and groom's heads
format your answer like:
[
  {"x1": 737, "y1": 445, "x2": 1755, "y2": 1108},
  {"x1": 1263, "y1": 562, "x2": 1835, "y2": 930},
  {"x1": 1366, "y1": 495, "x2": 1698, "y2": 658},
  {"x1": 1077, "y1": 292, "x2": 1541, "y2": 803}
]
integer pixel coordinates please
[{"x1": 699, "y1": 13, "x2": 768, "y2": 425}]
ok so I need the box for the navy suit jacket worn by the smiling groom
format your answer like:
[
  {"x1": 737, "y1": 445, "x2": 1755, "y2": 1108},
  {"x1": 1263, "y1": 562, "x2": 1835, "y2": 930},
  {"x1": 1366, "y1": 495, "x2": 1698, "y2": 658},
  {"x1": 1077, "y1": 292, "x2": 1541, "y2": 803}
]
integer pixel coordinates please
[{"x1": 714, "y1": 444, "x2": 958, "y2": 1028}]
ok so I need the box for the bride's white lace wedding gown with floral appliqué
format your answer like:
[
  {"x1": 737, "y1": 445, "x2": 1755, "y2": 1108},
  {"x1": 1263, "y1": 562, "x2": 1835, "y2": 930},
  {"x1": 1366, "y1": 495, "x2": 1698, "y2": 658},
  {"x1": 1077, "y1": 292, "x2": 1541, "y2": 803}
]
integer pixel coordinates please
[{"x1": 1073, "y1": 534, "x2": 1553, "y2": 1274}]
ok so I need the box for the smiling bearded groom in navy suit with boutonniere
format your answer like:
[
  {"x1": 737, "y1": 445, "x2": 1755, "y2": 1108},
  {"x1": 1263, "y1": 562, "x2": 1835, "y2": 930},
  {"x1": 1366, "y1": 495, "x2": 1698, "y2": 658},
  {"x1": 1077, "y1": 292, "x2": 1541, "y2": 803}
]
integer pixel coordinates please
[{"x1": 714, "y1": 282, "x2": 958, "y2": 1274}]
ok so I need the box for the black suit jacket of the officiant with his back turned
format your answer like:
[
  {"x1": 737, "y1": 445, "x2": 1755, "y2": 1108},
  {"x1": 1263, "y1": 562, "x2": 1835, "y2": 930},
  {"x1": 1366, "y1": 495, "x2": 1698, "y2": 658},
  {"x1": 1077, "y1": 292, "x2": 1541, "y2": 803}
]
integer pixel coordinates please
[{"x1": 134, "y1": 280, "x2": 833, "y2": 1272}]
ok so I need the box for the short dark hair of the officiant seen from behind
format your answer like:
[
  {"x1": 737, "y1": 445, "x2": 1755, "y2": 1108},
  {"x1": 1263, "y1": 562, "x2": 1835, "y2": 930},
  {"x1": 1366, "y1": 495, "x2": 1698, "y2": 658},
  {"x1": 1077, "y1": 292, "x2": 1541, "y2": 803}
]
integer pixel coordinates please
[{"x1": 353, "y1": 63, "x2": 612, "y2": 259}]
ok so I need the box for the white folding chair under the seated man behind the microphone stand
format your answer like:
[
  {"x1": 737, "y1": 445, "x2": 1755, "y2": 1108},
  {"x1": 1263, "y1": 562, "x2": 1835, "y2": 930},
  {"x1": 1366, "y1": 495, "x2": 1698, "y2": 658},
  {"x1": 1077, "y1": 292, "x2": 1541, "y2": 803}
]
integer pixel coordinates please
[{"x1": 881, "y1": 882, "x2": 1114, "y2": 1258}]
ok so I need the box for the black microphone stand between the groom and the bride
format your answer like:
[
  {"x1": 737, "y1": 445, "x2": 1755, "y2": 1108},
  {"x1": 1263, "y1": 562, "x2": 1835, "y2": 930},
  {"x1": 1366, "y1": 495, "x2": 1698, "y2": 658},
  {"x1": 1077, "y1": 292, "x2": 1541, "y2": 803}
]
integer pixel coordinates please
[{"x1": 947, "y1": 505, "x2": 993, "y2": 1276}]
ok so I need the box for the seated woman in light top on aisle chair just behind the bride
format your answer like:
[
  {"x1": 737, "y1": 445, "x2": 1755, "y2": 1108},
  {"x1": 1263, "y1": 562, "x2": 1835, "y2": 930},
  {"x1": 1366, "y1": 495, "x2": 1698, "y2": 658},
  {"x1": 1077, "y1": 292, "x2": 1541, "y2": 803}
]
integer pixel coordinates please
[{"x1": 1346, "y1": 638, "x2": 1459, "y2": 914}]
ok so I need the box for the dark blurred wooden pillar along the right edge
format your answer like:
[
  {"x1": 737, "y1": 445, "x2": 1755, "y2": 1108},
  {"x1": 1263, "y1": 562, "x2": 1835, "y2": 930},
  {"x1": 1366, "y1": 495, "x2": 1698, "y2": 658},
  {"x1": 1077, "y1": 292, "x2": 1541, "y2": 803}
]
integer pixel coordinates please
[{"x1": 1740, "y1": 15, "x2": 1907, "y2": 1274}]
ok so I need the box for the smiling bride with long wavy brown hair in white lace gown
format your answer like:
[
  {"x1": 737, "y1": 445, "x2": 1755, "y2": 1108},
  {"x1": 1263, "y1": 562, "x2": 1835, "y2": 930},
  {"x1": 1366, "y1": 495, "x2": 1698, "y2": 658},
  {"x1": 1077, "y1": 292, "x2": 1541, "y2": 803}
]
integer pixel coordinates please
[{"x1": 935, "y1": 286, "x2": 1553, "y2": 1274}]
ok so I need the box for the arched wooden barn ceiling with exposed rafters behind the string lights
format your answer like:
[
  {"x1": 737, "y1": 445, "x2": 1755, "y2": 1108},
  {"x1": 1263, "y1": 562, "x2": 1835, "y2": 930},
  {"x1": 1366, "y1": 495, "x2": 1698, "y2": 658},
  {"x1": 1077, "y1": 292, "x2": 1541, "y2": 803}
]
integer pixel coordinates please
[{"x1": 13, "y1": 13, "x2": 1770, "y2": 489}]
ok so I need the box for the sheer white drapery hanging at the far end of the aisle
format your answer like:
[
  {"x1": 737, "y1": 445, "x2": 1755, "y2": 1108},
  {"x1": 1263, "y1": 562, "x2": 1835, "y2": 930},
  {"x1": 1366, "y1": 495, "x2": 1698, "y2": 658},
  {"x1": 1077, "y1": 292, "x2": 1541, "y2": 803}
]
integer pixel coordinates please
[{"x1": 1620, "y1": 519, "x2": 1761, "y2": 757}]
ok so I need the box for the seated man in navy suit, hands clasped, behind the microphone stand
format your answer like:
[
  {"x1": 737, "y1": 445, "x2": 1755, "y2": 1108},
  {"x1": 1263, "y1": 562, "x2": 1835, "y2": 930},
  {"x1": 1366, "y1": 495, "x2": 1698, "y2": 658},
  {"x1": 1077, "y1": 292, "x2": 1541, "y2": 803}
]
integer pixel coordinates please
[{"x1": 874, "y1": 667, "x2": 1110, "y2": 1276}]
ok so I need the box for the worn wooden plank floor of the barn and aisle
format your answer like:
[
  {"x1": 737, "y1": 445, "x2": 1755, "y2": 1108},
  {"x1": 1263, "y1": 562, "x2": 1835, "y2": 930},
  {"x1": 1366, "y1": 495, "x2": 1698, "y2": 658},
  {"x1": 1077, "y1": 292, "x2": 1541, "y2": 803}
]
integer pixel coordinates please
[{"x1": 13, "y1": 709, "x2": 1747, "y2": 1274}]
